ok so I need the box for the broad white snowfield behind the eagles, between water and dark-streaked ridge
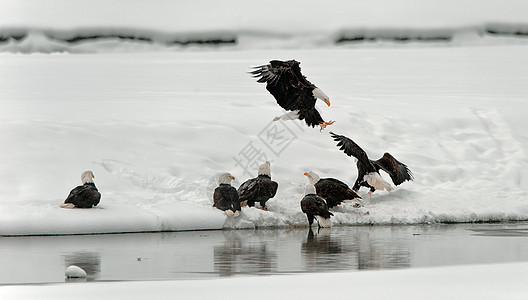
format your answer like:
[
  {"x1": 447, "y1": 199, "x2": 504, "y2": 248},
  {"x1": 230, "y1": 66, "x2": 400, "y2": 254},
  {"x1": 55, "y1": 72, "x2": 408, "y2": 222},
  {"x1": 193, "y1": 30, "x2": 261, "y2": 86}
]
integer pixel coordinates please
[{"x1": 0, "y1": 46, "x2": 528, "y2": 235}]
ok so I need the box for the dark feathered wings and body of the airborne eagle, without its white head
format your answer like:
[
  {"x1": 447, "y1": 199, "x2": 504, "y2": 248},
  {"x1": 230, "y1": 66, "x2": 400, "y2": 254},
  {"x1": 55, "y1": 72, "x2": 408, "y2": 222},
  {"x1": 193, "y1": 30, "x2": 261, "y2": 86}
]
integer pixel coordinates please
[{"x1": 250, "y1": 60, "x2": 317, "y2": 111}]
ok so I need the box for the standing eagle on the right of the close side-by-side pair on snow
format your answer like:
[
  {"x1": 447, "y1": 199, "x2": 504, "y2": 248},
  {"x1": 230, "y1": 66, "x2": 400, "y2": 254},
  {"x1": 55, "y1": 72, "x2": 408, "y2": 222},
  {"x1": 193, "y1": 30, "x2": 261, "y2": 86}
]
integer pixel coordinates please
[{"x1": 238, "y1": 161, "x2": 279, "y2": 210}]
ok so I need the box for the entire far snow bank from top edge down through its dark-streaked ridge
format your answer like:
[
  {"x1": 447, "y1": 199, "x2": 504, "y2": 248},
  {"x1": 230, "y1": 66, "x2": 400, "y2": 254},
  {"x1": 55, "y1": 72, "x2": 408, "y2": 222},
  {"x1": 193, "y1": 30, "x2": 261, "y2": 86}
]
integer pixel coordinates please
[{"x1": 0, "y1": 0, "x2": 528, "y2": 53}]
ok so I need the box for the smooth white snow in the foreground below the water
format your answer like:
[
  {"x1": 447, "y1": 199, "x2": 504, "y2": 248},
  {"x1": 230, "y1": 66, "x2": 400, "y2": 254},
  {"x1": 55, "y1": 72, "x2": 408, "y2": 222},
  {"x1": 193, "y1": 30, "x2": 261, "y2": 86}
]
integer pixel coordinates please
[{"x1": 0, "y1": 263, "x2": 528, "y2": 300}]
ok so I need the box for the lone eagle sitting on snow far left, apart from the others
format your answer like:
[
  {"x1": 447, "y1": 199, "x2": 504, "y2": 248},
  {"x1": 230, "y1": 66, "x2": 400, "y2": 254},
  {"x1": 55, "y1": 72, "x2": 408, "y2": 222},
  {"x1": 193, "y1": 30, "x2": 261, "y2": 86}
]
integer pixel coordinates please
[{"x1": 61, "y1": 171, "x2": 101, "y2": 208}]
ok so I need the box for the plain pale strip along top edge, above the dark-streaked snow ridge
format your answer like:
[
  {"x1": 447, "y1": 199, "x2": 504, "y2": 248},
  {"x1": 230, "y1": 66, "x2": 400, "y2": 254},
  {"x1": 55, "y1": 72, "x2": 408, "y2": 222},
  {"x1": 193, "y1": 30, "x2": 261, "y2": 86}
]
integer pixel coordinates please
[{"x1": 0, "y1": 0, "x2": 528, "y2": 31}]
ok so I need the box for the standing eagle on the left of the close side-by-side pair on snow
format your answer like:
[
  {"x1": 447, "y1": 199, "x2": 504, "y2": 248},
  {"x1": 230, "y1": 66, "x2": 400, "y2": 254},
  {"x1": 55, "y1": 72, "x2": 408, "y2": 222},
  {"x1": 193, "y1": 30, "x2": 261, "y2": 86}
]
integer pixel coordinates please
[{"x1": 213, "y1": 173, "x2": 240, "y2": 217}]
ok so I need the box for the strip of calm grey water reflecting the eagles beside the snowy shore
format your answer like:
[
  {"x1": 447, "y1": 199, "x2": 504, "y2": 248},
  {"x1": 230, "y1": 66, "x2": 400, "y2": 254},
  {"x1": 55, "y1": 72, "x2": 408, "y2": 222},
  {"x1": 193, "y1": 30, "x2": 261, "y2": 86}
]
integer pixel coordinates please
[{"x1": 0, "y1": 222, "x2": 528, "y2": 284}]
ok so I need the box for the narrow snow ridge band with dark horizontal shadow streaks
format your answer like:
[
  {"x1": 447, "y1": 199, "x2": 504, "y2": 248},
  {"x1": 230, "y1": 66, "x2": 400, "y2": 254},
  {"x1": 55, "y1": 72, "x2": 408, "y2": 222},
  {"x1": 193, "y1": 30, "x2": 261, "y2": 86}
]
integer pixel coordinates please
[{"x1": 0, "y1": 24, "x2": 528, "y2": 53}]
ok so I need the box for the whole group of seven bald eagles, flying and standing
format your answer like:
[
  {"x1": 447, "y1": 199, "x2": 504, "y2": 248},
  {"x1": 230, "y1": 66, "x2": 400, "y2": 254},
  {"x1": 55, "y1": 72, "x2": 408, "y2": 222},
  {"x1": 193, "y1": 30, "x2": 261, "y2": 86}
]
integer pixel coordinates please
[{"x1": 58, "y1": 60, "x2": 413, "y2": 227}]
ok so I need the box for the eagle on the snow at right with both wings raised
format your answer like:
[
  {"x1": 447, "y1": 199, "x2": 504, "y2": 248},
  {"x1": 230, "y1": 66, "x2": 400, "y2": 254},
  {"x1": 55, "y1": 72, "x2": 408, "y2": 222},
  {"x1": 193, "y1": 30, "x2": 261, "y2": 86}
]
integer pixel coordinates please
[{"x1": 330, "y1": 132, "x2": 414, "y2": 193}]
